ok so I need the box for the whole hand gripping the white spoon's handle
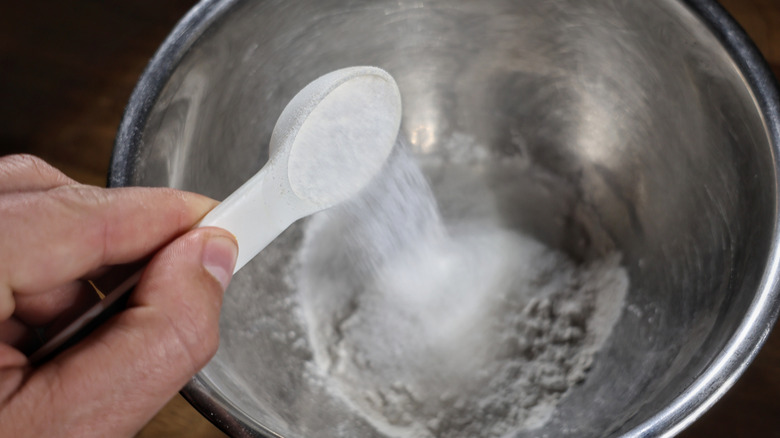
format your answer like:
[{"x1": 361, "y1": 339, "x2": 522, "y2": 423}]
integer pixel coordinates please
[{"x1": 0, "y1": 155, "x2": 237, "y2": 438}]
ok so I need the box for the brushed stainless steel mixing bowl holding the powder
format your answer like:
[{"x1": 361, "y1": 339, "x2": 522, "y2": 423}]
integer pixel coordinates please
[{"x1": 110, "y1": 0, "x2": 780, "y2": 438}]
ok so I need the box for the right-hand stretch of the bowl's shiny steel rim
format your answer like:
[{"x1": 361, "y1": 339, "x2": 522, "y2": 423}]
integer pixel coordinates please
[{"x1": 623, "y1": 0, "x2": 780, "y2": 438}]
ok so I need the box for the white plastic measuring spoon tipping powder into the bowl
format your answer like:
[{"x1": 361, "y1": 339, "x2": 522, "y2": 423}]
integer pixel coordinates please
[{"x1": 29, "y1": 67, "x2": 401, "y2": 364}]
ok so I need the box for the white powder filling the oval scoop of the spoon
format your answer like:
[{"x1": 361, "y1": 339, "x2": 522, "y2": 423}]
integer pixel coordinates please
[{"x1": 287, "y1": 69, "x2": 401, "y2": 205}]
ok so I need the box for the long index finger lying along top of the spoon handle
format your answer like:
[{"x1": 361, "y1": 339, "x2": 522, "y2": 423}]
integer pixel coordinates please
[{"x1": 0, "y1": 184, "x2": 216, "y2": 320}]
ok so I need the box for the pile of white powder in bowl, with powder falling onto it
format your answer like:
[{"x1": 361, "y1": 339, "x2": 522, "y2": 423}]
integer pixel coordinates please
[{"x1": 291, "y1": 135, "x2": 628, "y2": 438}]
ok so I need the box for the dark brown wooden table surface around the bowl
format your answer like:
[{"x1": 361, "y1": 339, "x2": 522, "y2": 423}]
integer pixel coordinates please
[{"x1": 0, "y1": 0, "x2": 780, "y2": 438}]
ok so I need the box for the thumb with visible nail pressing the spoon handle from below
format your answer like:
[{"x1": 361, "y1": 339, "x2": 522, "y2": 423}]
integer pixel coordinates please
[{"x1": 0, "y1": 228, "x2": 237, "y2": 436}]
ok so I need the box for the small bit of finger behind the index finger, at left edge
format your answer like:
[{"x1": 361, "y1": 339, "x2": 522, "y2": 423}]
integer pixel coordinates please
[{"x1": 0, "y1": 154, "x2": 76, "y2": 193}]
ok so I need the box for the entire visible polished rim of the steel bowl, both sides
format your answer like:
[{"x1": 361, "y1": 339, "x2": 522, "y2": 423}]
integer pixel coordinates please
[{"x1": 108, "y1": 0, "x2": 780, "y2": 438}]
